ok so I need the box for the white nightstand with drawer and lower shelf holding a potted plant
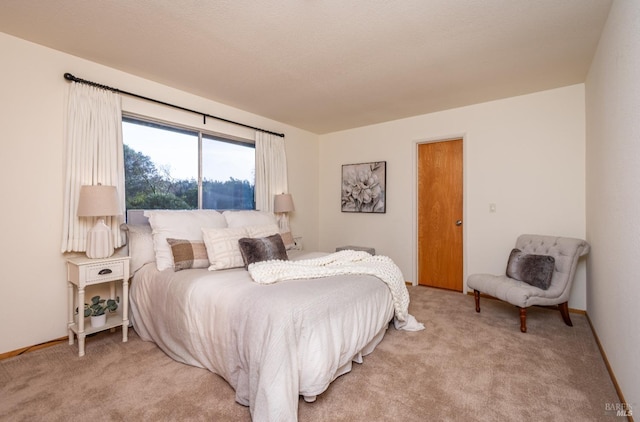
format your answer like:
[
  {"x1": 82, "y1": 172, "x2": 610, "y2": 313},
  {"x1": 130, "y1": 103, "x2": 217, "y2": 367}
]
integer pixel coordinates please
[{"x1": 67, "y1": 256, "x2": 129, "y2": 356}]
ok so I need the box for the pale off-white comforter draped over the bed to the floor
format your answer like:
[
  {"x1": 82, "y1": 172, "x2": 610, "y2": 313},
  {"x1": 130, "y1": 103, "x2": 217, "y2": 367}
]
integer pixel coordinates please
[{"x1": 131, "y1": 252, "x2": 394, "y2": 422}]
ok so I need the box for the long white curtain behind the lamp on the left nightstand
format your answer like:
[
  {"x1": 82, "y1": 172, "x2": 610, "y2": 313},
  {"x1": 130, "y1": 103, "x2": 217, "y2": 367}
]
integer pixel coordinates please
[{"x1": 61, "y1": 82, "x2": 125, "y2": 252}]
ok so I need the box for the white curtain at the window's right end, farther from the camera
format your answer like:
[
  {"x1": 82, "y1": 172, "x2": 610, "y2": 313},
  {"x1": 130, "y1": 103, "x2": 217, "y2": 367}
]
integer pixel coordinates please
[{"x1": 255, "y1": 131, "x2": 289, "y2": 212}]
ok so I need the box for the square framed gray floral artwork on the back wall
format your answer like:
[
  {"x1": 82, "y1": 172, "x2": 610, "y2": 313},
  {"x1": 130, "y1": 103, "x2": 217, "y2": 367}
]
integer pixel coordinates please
[{"x1": 342, "y1": 161, "x2": 387, "y2": 213}]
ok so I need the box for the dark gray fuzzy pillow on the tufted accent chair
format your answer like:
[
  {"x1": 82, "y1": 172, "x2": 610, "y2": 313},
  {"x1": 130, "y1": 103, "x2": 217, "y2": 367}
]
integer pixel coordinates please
[{"x1": 507, "y1": 249, "x2": 556, "y2": 290}]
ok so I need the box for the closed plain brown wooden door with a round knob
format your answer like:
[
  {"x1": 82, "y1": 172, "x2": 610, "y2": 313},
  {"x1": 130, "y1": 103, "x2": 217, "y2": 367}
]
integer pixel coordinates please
[{"x1": 418, "y1": 139, "x2": 462, "y2": 291}]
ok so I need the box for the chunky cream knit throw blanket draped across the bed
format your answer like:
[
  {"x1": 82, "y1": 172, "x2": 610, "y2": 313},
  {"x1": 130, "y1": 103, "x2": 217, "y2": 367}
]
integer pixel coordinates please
[{"x1": 248, "y1": 250, "x2": 424, "y2": 331}]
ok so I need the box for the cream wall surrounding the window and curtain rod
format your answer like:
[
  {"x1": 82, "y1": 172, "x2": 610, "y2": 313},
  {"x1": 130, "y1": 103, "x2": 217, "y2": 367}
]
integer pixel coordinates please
[{"x1": 0, "y1": 33, "x2": 318, "y2": 354}]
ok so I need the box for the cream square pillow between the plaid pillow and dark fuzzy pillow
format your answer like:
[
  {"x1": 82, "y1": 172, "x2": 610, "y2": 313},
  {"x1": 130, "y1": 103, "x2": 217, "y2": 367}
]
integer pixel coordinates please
[{"x1": 202, "y1": 227, "x2": 247, "y2": 271}]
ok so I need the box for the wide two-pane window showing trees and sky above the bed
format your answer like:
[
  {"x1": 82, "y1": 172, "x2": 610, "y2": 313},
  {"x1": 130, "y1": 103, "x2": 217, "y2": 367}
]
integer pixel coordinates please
[{"x1": 122, "y1": 117, "x2": 255, "y2": 210}]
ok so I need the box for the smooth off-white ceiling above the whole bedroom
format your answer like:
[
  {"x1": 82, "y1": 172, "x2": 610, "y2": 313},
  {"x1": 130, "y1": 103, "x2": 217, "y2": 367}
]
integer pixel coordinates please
[{"x1": 0, "y1": 0, "x2": 611, "y2": 134}]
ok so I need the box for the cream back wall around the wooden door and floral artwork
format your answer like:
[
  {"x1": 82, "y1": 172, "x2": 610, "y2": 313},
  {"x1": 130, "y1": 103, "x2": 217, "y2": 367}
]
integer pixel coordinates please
[{"x1": 320, "y1": 84, "x2": 586, "y2": 309}]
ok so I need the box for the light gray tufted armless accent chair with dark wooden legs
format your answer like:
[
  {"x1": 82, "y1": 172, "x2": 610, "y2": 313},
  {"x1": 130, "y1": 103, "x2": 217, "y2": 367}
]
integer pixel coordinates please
[{"x1": 467, "y1": 234, "x2": 590, "y2": 333}]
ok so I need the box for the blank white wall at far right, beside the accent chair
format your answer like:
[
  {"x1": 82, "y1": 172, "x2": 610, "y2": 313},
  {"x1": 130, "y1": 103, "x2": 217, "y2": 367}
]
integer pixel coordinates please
[{"x1": 586, "y1": 0, "x2": 640, "y2": 410}]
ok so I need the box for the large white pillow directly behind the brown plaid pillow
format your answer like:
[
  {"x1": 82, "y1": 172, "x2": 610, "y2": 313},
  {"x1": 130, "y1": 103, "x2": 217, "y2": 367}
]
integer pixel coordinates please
[{"x1": 144, "y1": 210, "x2": 227, "y2": 271}]
